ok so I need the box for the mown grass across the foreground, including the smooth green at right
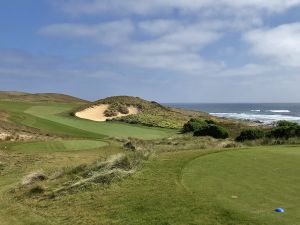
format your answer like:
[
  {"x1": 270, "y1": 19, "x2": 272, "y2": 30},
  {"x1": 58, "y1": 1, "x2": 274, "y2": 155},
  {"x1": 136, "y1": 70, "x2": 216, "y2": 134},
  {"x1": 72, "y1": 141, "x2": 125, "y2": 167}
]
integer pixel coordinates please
[{"x1": 0, "y1": 146, "x2": 300, "y2": 225}]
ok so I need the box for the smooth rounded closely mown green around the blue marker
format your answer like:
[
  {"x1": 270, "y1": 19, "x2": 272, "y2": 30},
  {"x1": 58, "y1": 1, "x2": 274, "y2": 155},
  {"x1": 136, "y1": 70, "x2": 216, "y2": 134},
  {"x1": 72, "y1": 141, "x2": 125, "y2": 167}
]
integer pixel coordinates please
[{"x1": 182, "y1": 146, "x2": 300, "y2": 224}]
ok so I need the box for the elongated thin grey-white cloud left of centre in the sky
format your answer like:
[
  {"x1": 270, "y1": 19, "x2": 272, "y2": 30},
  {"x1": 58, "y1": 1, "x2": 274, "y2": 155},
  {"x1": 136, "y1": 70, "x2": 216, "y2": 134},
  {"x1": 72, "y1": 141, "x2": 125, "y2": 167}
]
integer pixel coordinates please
[{"x1": 38, "y1": 20, "x2": 134, "y2": 45}]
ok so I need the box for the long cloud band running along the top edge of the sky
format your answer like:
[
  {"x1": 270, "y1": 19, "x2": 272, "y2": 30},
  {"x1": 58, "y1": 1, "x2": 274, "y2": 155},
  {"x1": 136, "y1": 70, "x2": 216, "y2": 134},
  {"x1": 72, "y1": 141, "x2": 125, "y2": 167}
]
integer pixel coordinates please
[{"x1": 55, "y1": 0, "x2": 300, "y2": 15}]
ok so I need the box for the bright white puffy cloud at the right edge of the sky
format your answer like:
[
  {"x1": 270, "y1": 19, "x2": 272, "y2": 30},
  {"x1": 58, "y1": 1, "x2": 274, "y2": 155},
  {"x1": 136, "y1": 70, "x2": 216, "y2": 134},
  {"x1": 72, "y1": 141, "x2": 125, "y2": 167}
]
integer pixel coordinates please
[{"x1": 244, "y1": 23, "x2": 300, "y2": 67}]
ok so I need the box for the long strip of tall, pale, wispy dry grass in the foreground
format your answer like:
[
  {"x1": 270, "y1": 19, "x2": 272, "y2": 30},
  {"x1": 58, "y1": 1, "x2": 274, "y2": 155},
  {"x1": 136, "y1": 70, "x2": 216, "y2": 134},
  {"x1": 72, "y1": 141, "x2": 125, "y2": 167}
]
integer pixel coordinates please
[{"x1": 11, "y1": 149, "x2": 151, "y2": 198}]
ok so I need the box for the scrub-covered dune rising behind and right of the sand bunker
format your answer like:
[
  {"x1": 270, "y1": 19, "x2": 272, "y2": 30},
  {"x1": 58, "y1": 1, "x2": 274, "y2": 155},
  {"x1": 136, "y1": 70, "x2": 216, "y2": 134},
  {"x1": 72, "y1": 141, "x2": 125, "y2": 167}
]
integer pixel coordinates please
[{"x1": 73, "y1": 96, "x2": 248, "y2": 136}]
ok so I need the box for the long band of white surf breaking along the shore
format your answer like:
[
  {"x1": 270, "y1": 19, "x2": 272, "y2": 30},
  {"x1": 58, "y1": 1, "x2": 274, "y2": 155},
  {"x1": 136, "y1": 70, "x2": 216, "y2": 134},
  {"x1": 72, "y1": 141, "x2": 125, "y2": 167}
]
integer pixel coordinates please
[{"x1": 210, "y1": 113, "x2": 300, "y2": 124}]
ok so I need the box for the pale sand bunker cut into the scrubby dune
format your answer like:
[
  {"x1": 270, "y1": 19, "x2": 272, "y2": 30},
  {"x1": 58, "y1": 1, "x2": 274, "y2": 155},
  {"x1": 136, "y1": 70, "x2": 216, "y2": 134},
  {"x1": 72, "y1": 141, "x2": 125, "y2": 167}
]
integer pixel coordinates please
[{"x1": 75, "y1": 104, "x2": 138, "y2": 121}]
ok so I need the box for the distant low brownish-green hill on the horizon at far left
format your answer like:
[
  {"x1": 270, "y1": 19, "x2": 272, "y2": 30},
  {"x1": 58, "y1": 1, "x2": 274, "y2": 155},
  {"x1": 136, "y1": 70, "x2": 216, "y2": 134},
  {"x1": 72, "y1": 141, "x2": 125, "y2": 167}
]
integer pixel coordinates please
[{"x1": 0, "y1": 91, "x2": 88, "y2": 104}]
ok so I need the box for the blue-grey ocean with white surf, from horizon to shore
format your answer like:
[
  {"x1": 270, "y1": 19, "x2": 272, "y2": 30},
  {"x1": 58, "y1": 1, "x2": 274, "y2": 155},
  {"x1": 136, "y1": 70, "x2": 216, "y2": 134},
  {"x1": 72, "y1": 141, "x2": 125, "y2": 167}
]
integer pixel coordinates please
[{"x1": 166, "y1": 103, "x2": 300, "y2": 124}]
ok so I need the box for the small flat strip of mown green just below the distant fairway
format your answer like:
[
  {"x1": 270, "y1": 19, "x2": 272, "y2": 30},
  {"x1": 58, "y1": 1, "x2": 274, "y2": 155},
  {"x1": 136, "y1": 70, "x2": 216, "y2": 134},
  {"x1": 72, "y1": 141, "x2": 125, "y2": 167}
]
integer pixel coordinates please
[{"x1": 7, "y1": 140, "x2": 107, "y2": 153}]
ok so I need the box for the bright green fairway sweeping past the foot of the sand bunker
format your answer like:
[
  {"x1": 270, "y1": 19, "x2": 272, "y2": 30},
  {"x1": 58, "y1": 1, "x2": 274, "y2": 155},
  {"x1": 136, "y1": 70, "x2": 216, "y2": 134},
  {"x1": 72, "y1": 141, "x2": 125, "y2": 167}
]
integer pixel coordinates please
[{"x1": 0, "y1": 101, "x2": 177, "y2": 139}]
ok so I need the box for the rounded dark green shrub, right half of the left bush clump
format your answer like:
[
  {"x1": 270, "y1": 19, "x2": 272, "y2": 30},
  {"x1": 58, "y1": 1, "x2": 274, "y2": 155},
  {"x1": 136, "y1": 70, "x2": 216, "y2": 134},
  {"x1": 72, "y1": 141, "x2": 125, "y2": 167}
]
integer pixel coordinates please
[{"x1": 194, "y1": 124, "x2": 229, "y2": 139}]
